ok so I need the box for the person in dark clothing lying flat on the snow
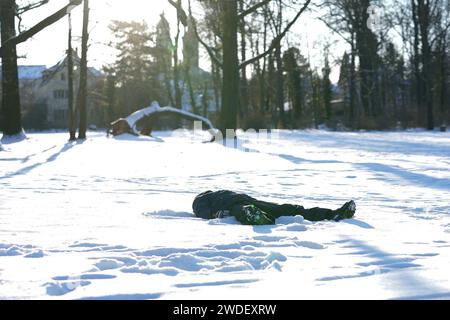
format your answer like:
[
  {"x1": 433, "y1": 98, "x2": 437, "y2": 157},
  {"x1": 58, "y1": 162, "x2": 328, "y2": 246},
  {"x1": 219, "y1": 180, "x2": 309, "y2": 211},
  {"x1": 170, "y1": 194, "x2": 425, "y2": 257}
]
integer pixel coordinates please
[{"x1": 192, "y1": 190, "x2": 356, "y2": 225}]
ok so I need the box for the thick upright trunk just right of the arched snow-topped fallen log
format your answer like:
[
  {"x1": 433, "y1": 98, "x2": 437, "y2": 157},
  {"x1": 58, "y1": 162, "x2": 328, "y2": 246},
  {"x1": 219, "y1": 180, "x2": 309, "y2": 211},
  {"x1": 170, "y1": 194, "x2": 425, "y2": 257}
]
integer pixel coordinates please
[{"x1": 220, "y1": 0, "x2": 239, "y2": 133}]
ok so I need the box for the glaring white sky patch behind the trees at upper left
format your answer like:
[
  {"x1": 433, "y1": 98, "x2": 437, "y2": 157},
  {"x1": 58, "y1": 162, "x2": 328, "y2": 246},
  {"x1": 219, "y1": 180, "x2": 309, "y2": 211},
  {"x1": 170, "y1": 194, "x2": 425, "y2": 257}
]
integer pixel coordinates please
[{"x1": 19, "y1": 0, "x2": 178, "y2": 67}]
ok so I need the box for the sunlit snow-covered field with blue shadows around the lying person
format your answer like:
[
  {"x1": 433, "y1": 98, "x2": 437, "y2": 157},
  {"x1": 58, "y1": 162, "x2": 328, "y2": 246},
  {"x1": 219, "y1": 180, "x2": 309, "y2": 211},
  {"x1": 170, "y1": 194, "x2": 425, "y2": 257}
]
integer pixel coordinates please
[{"x1": 0, "y1": 131, "x2": 450, "y2": 299}]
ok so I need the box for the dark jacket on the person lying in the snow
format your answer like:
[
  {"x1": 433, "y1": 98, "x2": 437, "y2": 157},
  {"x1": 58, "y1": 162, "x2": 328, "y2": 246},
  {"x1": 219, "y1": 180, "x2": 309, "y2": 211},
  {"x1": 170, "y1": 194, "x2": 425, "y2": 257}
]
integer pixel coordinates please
[{"x1": 192, "y1": 190, "x2": 258, "y2": 219}]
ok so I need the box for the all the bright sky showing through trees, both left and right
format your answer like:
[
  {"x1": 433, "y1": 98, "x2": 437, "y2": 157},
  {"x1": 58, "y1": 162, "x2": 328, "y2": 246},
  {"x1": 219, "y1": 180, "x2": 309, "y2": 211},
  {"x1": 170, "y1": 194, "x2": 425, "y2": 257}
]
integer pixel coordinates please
[{"x1": 14, "y1": 0, "x2": 345, "y2": 81}]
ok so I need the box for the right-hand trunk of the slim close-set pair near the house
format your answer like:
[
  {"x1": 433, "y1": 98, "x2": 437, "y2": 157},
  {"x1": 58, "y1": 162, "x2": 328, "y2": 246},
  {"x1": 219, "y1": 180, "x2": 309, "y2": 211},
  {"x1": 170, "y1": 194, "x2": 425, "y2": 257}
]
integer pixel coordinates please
[{"x1": 77, "y1": 0, "x2": 89, "y2": 140}]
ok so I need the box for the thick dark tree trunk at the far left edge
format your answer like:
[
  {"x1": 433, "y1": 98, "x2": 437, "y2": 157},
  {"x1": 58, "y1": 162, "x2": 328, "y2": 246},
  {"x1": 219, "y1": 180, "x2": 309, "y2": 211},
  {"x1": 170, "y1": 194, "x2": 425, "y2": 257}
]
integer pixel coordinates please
[{"x1": 0, "y1": 0, "x2": 22, "y2": 136}]
